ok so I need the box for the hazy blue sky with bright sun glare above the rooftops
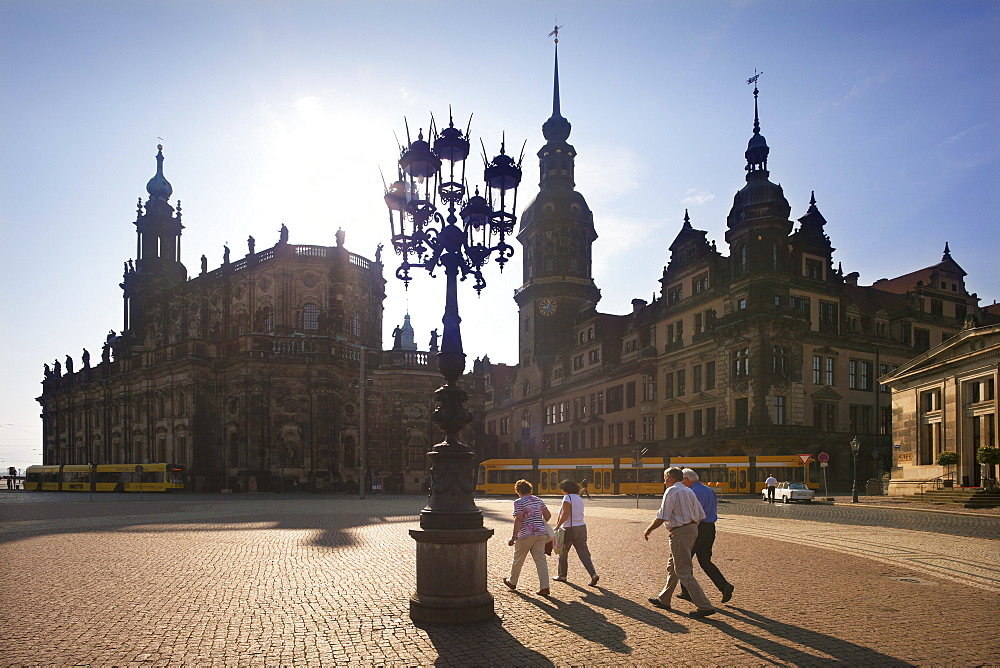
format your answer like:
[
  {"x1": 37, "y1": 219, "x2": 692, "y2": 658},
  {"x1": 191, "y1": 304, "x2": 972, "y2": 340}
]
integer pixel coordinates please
[{"x1": 0, "y1": 0, "x2": 1000, "y2": 469}]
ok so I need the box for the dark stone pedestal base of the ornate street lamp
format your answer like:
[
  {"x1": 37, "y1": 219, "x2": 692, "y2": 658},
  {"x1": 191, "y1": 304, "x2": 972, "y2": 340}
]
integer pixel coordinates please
[{"x1": 410, "y1": 528, "x2": 495, "y2": 624}]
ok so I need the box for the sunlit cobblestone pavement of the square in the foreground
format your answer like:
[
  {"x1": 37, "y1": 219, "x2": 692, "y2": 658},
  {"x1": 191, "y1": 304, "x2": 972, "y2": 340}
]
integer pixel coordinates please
[{"x1": 0, "y1": 494, "x2": 1000, "y2": 666}]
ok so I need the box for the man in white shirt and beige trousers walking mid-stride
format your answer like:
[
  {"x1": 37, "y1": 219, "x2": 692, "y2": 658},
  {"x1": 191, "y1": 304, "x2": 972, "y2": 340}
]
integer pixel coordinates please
[{"x1": 642, "y1": 466, "x2": 715, "y2": 617}]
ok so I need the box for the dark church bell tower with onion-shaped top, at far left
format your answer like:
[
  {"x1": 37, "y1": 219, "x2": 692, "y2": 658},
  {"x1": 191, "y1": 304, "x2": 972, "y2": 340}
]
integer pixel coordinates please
[{"x1": 121, "y1": 145, "x2": 187, "y2": 344}]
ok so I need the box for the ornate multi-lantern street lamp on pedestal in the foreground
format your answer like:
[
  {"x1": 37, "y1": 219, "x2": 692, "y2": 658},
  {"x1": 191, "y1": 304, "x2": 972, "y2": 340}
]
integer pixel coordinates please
[{"x1": 385, "y1": 114, "x2": 524, "y2": 624}]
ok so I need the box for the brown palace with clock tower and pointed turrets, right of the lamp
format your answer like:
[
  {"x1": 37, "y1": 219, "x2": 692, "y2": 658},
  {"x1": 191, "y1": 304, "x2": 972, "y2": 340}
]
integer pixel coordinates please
[{"x1": 480, "y1": 47, "x2": 996, "y2": 492}]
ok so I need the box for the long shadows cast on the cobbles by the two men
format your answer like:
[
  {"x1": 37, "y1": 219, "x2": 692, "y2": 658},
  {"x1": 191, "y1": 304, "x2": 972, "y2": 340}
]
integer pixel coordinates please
[{"x1": 705, "y1": 606, "x2": 913, "y2": 666}]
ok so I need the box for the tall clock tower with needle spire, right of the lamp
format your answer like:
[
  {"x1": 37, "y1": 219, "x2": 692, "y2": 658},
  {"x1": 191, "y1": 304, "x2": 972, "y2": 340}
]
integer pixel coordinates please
[{"x1": 514, "y1": 31, "x2": 601, "y2": 376}]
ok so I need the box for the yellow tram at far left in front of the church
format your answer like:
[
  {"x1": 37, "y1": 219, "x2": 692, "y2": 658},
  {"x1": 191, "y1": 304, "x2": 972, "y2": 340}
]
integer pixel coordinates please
[{"x1": 24, "y1": 464, "x2": 184, "y2": 492}]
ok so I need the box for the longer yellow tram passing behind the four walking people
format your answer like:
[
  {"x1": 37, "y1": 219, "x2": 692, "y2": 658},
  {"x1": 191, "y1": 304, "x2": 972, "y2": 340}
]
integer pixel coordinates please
[{"x1": 476, "y1": 455, "x2": 819, "y2": 494}]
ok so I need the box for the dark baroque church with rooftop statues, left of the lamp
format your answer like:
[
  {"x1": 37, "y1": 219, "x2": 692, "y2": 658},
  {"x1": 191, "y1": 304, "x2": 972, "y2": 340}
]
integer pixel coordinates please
[{"x1": 38, "y1": 147, "x2": 454, "y2": 492}]
